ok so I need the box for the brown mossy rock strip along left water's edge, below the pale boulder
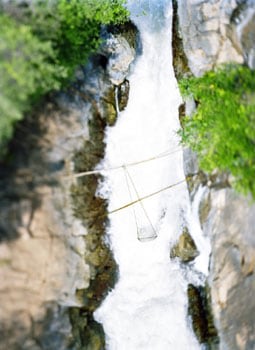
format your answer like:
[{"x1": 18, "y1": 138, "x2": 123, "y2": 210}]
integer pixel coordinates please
[{"x1": 69, "y1": 103, "x2": 117, "y2": 350}]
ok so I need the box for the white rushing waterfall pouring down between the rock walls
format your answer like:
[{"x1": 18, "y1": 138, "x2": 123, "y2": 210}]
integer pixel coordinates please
[{"x1": 95, "y1": 0, "x2": 209, "y2": 350}]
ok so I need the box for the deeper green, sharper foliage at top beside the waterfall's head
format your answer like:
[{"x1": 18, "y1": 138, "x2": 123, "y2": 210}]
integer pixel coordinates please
[{"x1": 23, "y1": 0, "x2": 128, "y2": 75}]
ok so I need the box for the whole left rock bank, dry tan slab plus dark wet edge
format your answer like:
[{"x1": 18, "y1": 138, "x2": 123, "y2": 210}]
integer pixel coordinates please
[{"x1": 0, "y1": 24, "x2": 137, "y2": 350}]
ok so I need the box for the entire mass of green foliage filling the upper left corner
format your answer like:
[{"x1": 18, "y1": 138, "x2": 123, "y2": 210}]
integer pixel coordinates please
[{"x1": 0, "y1": 0, "x2": 128, "y2": 153}]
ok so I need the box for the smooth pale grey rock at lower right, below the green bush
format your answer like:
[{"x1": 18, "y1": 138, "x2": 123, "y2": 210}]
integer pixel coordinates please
[{"x1": 204, "y1": 189, "x2": 255, "y2": 350}]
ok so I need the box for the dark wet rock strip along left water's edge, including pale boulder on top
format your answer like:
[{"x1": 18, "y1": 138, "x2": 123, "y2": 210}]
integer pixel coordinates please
[{"x1": 65, "y1": 24, "x2": 136, "y2": 350}]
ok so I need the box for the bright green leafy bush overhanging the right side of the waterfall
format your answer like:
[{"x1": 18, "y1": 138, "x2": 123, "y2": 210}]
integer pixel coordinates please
[{"x1": 180, "y1": 64, "x2": 255, "y2": 198}]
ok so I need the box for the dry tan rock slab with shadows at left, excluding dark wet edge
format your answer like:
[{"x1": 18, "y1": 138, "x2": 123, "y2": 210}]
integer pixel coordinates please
[{"x1": 0, "y1": 98, "x2": 89, "y2": 350}]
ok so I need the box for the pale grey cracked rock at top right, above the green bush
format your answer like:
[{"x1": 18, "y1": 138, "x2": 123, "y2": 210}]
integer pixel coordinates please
[{"x1": 178, "y1": 0, "x2": 255, "y2": 76}]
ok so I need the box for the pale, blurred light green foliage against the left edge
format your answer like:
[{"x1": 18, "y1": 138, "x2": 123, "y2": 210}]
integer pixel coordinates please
[{"x1": 0, "y1": 15, "x2": 66, "y2": 145}]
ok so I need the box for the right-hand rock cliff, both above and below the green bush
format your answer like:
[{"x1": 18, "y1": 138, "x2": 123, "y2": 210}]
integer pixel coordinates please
[{"x1": 175, "y1": 0, "x2": 255, "y2": 350}]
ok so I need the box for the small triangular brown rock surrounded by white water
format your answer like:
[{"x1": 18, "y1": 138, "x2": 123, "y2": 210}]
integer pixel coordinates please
[{"x1": 170, "y1": 227, "x2": 199, "y2": 263}]
